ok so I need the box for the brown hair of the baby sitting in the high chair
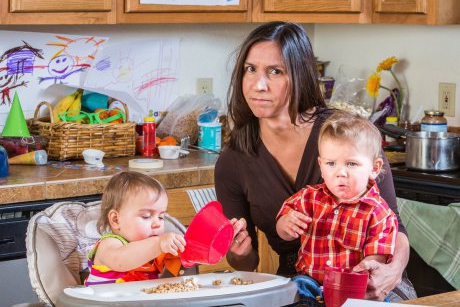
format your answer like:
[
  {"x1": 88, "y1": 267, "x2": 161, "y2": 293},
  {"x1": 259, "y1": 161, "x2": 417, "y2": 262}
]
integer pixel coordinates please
[{"x1": 97, "y1": 171, "x2": 166, "y2": 233}]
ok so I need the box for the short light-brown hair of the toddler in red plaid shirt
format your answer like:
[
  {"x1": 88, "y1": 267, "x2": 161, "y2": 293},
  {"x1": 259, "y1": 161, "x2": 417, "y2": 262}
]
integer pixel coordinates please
[{"x1": 318, "y1": 111, "x2": 382, "y2": 160}]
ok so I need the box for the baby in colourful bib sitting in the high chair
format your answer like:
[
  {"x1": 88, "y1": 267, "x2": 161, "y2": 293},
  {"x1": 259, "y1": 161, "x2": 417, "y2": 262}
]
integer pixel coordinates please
[{"x1": 85, "y1": 171, "x2": 185, "y2": 286}]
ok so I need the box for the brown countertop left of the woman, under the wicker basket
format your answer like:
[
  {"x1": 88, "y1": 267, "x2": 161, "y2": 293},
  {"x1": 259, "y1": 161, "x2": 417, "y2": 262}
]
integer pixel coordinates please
[{"x1": 0, "y1": 151, "x2": 218, "y2": 205}]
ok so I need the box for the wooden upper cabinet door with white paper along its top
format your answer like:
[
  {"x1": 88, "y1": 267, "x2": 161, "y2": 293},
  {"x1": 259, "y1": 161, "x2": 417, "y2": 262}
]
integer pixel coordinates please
[{"x1": 117, "y1": 0, "x2": 251, "y2": 23}]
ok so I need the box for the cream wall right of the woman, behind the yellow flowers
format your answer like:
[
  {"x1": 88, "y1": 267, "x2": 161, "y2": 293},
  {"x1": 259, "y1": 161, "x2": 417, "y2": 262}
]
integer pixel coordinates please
[{"x1": 314, "y1": 24, "x2": 460, "y2": 126}]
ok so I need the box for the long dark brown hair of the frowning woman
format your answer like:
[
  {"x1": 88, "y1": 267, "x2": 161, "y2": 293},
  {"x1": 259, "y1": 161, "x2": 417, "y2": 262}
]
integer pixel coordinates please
[{"x1": 226, "y1": 21, "x2": 326, "y2": 155}]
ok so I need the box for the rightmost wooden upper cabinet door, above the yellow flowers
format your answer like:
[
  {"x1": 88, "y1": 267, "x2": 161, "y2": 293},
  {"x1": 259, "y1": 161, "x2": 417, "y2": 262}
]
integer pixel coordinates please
[{"x1": 372, "y1": 0, "x2": 460, "y2": 25}]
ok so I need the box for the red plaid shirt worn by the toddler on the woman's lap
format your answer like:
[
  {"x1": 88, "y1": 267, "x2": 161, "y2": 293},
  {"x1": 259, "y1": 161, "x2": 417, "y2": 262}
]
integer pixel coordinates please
[{"x1": 276, "y1": 181, "x2": 398, "y2": 284}]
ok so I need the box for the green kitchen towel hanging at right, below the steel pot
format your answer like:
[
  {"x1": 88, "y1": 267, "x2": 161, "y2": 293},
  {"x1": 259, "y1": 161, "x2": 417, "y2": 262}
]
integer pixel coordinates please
[{"x1": 398, "y1": 198, "x2": 460, "y2": 289}]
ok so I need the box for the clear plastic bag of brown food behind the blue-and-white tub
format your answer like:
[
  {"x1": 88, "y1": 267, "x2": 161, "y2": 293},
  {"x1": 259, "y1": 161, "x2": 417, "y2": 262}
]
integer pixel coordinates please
[{"x1": 157, "y1": 94, "x2": 221, "y2": 144}]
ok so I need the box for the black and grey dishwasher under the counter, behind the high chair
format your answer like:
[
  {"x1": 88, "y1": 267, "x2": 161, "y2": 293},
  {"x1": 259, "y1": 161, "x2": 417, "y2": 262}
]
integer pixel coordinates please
[{"x1": 0, "y1": 195, "x2": 101, "y2": 306}]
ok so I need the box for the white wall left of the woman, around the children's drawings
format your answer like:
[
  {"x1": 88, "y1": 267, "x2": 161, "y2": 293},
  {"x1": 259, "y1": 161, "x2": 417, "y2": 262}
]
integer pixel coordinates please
[{"x1": 0, "y1": 24, "x2": 264, "y2": 127}]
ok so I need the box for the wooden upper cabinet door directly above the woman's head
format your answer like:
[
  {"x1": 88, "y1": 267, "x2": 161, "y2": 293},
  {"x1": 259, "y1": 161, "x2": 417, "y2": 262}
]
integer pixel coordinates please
[{"x1": 253, "y1": 0, "x2": 371, "y2": 23}]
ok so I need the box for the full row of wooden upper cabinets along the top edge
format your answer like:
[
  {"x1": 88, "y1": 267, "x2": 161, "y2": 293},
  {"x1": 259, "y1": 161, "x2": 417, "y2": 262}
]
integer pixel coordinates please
[{"x1": 0, "y1": 0, "x2": 460, "y2": 25}]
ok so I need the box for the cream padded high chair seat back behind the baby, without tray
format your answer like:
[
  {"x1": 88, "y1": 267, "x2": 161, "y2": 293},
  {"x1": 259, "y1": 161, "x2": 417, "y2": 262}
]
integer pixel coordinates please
[{"x1": 26, "y1": 201, "x2": 198, "y2": 306}]
